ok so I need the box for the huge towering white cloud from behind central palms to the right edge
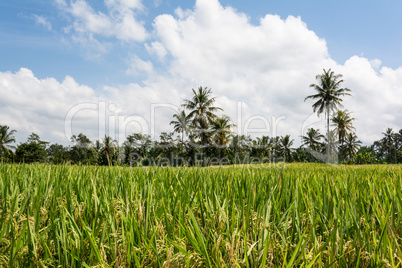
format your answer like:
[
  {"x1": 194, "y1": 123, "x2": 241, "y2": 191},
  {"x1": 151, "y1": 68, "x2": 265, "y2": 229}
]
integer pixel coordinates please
[{"x1": 145, "y1": 0, "x2": 402, "y2": 143}]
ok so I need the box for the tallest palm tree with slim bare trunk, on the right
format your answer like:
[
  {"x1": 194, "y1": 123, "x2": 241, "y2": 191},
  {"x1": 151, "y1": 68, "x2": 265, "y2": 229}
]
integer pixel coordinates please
[{"x1": 304, "y1": 69, "x2": 351, "y2": 161}]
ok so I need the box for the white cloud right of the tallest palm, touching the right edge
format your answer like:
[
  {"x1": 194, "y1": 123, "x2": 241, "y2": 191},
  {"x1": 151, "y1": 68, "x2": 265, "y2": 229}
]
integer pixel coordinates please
[{"x1": 338, "y1": 56, "x2": 402, "y2": 142}]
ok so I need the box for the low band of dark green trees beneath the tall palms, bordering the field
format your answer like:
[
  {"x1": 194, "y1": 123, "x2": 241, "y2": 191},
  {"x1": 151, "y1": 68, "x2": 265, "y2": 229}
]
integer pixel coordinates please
[{"x1": 0, "y1": 125, "x2": 402, "y2": 166}]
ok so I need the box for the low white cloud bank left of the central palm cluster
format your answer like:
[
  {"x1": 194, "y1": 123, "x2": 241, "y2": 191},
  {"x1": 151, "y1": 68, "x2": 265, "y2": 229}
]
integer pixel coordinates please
[{"x1": 0, "y1": 68, "x2": 179, "y2": 144}]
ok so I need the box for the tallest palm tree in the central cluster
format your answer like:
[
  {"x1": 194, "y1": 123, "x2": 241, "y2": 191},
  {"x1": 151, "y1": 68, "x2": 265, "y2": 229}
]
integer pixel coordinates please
[{"x1": 182, "y1": 87, "x2": 222, "y2": 145}]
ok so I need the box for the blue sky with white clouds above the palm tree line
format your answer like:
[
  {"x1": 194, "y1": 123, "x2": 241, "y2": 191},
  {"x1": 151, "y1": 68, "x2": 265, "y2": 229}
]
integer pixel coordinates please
[{"x1": 0, "y1": 0, "x2": 402, "y2": 147}]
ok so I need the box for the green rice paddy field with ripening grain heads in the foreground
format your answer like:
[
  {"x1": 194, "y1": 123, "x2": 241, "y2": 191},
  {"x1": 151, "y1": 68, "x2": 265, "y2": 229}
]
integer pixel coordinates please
[{"x1": 0, "y1": 164, "x2": 402, "y2": 267}]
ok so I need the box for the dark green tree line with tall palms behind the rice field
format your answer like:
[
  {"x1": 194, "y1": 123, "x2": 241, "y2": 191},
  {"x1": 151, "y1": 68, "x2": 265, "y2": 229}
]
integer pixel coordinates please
[{"x1": 0, "y1": 69, "x2": 402, "y2": 166}]
